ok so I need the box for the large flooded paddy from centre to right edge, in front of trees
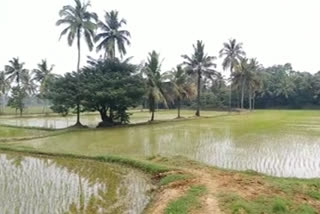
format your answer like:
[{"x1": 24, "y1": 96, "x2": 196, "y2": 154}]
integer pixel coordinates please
[{"x1": 5, "y1": 110, "x2": 320, "y2": 178}]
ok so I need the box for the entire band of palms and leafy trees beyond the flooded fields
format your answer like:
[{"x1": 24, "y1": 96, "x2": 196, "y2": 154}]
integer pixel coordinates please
[{"x1": 0, "y1": 0, "x2": 320, "y2": 126}]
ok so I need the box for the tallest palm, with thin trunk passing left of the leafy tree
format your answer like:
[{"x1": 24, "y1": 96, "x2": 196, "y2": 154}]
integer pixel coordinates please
[{"x1": 56, "y1": 0, "x2": 98, "y2": 125}]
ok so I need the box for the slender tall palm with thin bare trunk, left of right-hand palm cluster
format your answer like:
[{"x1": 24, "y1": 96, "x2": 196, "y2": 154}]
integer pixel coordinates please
[{"x1": 219, "y1": 39, "x2": 245, "y2": 111}]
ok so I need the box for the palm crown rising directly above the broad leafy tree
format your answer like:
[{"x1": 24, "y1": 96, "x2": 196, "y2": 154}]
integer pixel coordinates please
[{"x1": 95, "y1": 10, "x2": 130, "y2": 58}]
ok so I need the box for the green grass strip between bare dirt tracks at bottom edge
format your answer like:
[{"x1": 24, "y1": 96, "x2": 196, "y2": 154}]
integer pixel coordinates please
[{"x1": 165, "y1": 186, "x2": 207, "y2": 214}]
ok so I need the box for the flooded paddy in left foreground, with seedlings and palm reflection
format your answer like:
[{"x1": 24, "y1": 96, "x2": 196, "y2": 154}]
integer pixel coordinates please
[{"x1": 0, "y1": 153, "x2": 151, "y2": 214}]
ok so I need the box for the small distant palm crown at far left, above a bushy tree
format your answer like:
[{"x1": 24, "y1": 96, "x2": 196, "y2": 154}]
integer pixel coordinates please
[{"x1": 5, "y1": 57, "x2": 27, "y2": 87}]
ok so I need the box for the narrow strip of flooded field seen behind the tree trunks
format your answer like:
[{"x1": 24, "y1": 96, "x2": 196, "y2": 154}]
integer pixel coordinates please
[{"x1": 0, "y1": 110, "x2": 225, "y2": 129}]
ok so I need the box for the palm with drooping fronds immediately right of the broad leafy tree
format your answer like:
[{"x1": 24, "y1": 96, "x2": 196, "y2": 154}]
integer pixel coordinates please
[{"x1": 142, "y1": 51, "x2": 167, "y2": 121}]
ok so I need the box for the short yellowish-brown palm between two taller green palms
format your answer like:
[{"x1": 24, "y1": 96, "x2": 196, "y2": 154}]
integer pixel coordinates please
[{"x1": 164, "y1": 65, "x2": 196, "y2": 118}]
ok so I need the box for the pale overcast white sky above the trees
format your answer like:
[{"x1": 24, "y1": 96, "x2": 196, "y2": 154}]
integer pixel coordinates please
[{"x1": 0, "y1": 0, "x2": 320, "y2": 76}]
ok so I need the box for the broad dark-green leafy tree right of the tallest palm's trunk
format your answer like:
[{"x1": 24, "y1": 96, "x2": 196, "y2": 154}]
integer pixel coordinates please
[{"x1": 80, "y1": 58, "x2": 144, "y2": 126}]
